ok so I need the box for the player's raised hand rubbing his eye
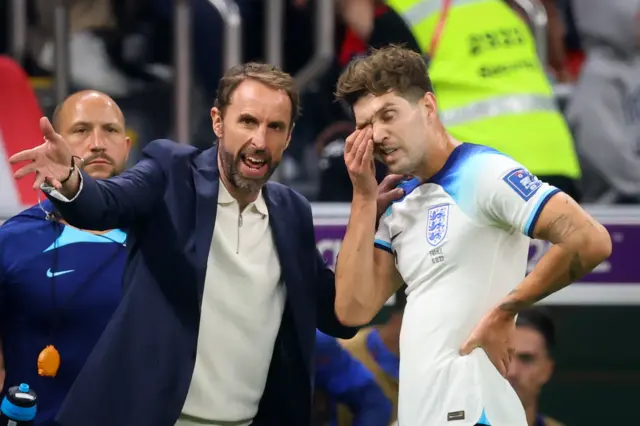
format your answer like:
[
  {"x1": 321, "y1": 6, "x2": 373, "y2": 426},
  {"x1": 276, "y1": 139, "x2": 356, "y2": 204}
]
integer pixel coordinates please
[{"x1": 344, "y1": 126, "x2": 378, "y2": 200}]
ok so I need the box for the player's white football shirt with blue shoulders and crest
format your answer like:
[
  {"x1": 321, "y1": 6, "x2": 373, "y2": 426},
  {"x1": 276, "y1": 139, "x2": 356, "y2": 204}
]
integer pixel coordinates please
[{"x1": 375, "y1": 143, "x2": 559, "y2": 426}]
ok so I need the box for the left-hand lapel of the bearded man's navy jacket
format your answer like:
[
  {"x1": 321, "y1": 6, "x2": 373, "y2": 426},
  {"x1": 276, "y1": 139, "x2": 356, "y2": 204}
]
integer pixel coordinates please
[{"x1": 193, "y1": 146, "x2": 220, "y2": 306}]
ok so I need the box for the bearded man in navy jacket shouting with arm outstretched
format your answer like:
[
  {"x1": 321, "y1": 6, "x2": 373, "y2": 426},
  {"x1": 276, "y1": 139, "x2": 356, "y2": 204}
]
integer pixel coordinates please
[{"x1": 11, "y1": 63, "x2": 401, "y2": 426}]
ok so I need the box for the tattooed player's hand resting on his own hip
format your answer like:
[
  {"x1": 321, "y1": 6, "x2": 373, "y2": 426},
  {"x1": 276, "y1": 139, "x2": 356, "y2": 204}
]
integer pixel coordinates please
[{"x1": 460, "y1": 311, "x2": 515, "y2": 377}]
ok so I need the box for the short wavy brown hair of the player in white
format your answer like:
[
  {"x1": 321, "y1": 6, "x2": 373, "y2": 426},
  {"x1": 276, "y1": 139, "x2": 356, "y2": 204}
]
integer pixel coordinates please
[{"x1": 336, "y1": 45, "x2": 433, "y2": 106}]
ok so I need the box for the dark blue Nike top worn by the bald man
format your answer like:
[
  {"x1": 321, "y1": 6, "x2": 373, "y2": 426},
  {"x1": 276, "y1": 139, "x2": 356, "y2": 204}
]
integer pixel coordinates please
[{"x1": 0, "y1": 200, "x2": 127, "y2": 426}]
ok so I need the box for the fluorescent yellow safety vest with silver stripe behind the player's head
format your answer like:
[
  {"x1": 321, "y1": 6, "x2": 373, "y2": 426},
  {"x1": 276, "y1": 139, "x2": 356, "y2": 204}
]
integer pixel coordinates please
[{"x1": 387, "y1": 0, "x2": 580, "y2": 179}]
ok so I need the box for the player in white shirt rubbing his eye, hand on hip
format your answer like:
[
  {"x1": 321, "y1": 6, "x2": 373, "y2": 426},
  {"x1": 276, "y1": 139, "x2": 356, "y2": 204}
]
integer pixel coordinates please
[{"x1": 336, "y1": 47, "x2": 611, "y2": 426}]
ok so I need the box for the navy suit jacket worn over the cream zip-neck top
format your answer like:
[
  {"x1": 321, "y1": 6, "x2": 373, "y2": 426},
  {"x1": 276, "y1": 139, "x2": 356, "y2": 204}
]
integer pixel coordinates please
[{"x1": 47, "y1": 140, "x2": 356, "y2": 426}]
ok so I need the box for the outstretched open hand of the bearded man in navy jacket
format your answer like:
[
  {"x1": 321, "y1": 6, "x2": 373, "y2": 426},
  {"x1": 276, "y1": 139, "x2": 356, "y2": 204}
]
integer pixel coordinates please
[{"x1": 9, "y1": 117, "x2": 72, "y2": 190}]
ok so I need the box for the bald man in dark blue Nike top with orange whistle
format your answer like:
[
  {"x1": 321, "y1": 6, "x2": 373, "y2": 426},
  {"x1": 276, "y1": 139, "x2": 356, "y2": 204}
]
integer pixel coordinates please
[{"x1": 0, "y1": 91, "x2": 131, "y2": 426}]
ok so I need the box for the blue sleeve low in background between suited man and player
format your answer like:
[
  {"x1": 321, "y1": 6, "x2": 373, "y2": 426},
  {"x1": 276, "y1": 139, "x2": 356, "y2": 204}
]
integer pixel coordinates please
[{"x1": 316, "y1": 331, "x2": 393, "y2": 426}]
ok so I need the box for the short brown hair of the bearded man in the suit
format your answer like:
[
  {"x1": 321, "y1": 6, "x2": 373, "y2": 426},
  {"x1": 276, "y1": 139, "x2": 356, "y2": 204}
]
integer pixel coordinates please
[{"x1": 213, "y1": 62, "x2": 300, "y2": 128}]
